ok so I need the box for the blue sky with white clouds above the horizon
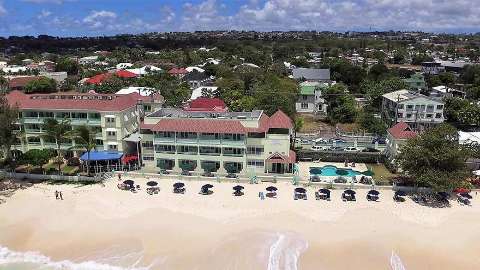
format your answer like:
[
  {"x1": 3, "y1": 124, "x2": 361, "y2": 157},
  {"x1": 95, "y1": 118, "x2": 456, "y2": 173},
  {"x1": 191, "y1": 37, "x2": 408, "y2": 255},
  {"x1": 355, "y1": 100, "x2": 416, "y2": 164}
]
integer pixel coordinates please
[{"x1": 0, "y1": 0, "x2": 480, "y2": 36}]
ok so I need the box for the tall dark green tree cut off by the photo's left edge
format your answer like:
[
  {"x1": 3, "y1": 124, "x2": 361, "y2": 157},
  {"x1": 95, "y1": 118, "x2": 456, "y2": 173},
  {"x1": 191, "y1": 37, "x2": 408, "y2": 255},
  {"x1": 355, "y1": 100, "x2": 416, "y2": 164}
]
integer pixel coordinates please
[{"x1": 0, "y1": 94, "x2": 18, "y2": 159}]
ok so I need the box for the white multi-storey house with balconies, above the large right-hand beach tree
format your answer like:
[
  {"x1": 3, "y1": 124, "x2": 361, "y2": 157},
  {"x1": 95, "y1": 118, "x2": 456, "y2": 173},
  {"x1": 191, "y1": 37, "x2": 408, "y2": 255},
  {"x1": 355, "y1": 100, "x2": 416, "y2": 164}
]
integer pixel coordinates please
[{"x1": 382, "y1": 89, "x2": 445, "y2": 130}]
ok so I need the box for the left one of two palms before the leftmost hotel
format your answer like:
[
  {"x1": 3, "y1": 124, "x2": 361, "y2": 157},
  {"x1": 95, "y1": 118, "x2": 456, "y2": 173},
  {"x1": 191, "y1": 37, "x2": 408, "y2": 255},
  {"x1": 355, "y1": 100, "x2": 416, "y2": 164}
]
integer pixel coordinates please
[{"x1": 42, "y1": 118, "x2": 72, "y2": 174}]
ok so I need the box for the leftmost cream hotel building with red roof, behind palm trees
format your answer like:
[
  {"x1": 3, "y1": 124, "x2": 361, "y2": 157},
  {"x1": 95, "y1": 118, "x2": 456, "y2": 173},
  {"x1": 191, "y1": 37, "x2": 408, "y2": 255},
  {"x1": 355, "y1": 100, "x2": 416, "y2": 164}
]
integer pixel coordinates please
[{"x1": 7, "y1": 91, "x2": 163, "y2": 156}]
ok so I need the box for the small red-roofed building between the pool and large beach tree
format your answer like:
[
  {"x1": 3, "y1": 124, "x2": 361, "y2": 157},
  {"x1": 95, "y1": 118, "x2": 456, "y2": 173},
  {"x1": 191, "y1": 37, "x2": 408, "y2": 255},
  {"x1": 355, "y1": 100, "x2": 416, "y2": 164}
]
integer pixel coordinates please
[{"x1": 386, "y1": 122, "x2": 418, "y2": 159}]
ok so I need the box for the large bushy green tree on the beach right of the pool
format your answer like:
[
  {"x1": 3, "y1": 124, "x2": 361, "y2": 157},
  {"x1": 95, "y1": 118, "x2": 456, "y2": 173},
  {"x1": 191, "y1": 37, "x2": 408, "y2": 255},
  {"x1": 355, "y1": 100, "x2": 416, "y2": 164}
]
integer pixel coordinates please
[{"x1": 396, "y1": 124, "x2": 470, "y2": 191}]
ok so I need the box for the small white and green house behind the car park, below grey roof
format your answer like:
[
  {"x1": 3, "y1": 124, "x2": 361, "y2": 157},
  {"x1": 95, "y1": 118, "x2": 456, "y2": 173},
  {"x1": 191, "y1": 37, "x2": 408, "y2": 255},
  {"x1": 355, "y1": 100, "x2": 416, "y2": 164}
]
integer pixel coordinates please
[{"x1": 295, "y1": 81, "x2": 328, "y2": 114}]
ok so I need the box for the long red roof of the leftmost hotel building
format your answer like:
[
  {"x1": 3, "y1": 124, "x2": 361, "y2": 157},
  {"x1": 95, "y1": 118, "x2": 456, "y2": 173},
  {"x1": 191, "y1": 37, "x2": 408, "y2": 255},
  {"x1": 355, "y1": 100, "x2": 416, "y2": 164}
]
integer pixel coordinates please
[{"x1": 7, "y1": 91, "x2": 146, "y2": 112}]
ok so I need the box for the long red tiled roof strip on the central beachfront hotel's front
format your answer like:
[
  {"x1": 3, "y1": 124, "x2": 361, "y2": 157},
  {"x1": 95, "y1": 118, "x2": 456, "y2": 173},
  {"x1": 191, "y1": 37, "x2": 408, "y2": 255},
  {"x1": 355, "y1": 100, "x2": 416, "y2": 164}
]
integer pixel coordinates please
[{"x1": 151, "y1": 118, "x2": 246, "y2": 134}]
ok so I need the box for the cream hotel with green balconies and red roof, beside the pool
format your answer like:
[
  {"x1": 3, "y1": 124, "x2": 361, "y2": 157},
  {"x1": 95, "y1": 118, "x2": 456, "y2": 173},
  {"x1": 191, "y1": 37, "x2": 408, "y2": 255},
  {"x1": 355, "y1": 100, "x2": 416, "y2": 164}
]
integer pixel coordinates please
[{"x1": 140, "y1": 108, "x2": 296, "y2": 176}]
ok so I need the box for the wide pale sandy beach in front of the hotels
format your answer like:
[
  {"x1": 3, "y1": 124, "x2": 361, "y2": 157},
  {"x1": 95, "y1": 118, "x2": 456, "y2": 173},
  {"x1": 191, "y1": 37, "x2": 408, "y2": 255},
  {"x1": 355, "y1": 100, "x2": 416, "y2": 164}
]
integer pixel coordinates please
[{"x1": 0, "y1": 178, "x2": 480, "y2": 270}]
